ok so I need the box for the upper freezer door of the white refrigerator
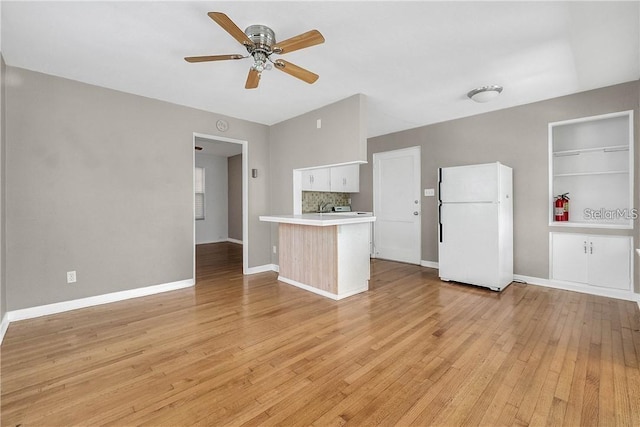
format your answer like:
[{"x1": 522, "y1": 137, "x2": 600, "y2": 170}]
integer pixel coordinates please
[{"x1": 439, "y1": 163, "x2": 500, "y2": 202}]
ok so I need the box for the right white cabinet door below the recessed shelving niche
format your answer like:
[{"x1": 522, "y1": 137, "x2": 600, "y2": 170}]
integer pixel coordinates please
[{"x1": 588, "y1": 236, "x2": 631, "y2": 290}]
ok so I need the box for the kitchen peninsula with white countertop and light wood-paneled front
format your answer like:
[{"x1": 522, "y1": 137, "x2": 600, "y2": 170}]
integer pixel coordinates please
[{"x1": 260, "y1": 213, "x2": 376, "y2": 300}]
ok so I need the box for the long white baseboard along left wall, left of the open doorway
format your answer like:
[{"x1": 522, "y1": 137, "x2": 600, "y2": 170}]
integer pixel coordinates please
[{"x1": 7, "y1": 279, "x2": 195, "y2": 322}]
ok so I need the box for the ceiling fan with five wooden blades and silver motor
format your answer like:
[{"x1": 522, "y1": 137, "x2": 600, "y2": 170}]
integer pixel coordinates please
[{"x1": 184, "y1": 12, "x2": 324, "y2": 89}]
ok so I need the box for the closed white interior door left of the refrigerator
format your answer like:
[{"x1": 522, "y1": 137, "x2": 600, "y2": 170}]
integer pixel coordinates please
[{"x1": 373, "y1": 147, "x2": 422, "y2": 264}]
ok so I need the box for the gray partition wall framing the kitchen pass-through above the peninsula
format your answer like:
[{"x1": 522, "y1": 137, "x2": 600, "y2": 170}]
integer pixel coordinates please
[{"x1": 269, "y1": 95, "x2": 367, "y2": 264}]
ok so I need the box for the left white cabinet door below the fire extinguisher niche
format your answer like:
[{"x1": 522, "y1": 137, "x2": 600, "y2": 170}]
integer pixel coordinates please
[{"x1": 551, "y1": 233, "x2": 589, "y2": 283}]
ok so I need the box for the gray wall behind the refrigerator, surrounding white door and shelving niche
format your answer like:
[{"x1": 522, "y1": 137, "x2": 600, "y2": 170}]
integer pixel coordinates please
[{"x1": 352, "y1": 82, "x2": 640, "y2": 288}]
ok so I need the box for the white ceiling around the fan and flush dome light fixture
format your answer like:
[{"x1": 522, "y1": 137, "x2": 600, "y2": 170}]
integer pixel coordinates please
[{"x1": 1, "y1": 1, "x2": 640, "y2": 136}]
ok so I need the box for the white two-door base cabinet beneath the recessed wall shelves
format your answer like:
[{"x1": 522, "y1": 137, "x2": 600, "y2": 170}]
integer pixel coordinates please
[{"x1": 549, "y1": 233, "x2": 633, "y2": 291}]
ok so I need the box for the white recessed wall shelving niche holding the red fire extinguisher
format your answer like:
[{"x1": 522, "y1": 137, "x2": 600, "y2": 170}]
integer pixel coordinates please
[{"x1": 549, "y1": 111, "x2": 636, "y2": 229}]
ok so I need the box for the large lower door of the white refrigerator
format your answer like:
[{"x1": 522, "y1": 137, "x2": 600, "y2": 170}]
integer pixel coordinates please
[{"x1": 438, "y1": 203, "x2": 502, "y2": 287}]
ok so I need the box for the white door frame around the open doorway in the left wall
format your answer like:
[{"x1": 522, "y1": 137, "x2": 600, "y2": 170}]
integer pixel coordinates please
[{"x1": 191, "y1": 132, "x2": 249, "y2": 276}]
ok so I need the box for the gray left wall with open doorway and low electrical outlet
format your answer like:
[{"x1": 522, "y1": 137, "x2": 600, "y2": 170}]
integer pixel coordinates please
[{"x1": 5, "y1": 67, "x2": 271, "y2": 310}]
